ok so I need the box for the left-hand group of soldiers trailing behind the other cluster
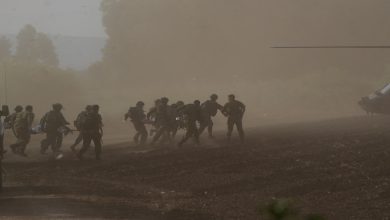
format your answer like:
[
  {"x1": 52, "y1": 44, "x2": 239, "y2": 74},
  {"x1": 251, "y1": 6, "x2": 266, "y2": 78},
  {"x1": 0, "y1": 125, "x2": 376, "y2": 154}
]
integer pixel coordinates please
[{"x1": 4, "y1": 103, "x2": 103, "y2": 160}]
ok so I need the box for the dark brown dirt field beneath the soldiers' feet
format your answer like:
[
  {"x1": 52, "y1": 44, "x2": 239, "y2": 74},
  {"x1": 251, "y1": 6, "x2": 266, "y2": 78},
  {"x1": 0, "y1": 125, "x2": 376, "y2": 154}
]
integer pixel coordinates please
[{"x1": 0, "y1": 117, "x2": 390, "y2": 220}]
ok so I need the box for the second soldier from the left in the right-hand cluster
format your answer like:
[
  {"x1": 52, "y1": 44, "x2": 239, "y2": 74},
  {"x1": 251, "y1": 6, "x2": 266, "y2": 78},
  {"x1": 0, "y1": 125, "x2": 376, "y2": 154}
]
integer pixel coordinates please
[{"x1": 151, "y1": 97, "x2": 171, "y2": 145}]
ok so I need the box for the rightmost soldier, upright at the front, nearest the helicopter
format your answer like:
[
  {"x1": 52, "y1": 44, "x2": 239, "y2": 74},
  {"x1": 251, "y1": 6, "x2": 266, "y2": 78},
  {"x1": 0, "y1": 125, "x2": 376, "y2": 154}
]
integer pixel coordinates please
[{"x1": 222, "y1": 95, "x2": 245, "y2": 142}]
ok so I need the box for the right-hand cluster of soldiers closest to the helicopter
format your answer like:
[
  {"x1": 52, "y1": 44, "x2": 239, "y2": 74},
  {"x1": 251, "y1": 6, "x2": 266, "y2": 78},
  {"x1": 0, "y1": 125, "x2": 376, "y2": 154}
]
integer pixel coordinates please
[{"x1": 125, "y1": 94, "x2": 245, "y2": 147}]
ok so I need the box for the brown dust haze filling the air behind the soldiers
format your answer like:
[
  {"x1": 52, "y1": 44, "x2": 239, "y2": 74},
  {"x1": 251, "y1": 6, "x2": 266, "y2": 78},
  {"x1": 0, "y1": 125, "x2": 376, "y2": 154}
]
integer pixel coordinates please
[{"x1": 0, "y1": 0, "x2": 390, "y2": 126}]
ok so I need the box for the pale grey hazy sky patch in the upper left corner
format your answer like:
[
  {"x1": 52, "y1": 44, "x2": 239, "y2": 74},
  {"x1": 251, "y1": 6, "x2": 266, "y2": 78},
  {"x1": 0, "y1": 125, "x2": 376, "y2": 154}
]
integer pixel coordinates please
[{"x1": 0, "y1": 0, "x2": 105, "y2": 36}]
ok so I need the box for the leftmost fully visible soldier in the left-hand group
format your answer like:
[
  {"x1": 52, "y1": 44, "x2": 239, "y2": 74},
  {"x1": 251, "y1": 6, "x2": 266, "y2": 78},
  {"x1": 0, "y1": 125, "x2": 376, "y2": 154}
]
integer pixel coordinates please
[{"x1": 10, "y1": 105, "x2": 35, "y2": 157}]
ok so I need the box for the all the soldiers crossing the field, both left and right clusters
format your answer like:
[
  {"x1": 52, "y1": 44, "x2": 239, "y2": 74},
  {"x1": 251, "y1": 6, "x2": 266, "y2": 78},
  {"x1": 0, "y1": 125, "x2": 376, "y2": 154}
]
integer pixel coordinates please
[{"x1": 3, "y1": 94, "x2": 245, "y2": 160}]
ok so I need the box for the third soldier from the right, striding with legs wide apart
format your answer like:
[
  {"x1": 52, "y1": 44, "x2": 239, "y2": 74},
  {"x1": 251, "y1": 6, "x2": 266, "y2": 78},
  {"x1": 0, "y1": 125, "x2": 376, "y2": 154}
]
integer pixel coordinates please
[{"x1": 178, "y1": 100, "x2": 201, "y2": 147}]
